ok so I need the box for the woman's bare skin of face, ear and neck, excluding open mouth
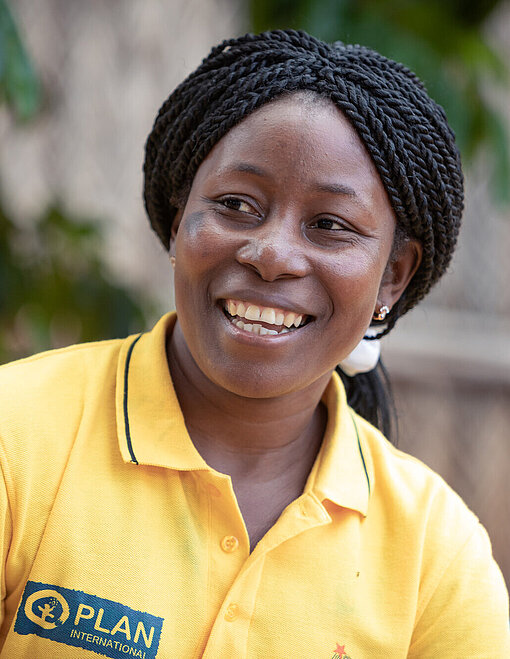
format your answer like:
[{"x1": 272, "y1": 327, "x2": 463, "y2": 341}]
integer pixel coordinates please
[{"x1": 167, "y1": 94, "x2": 421, "y2": 547}]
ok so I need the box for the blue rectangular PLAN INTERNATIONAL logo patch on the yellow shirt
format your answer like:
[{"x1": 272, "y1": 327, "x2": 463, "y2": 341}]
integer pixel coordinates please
[{"x1": 14, "y1": 581, "x2": 163, "y2": 659}]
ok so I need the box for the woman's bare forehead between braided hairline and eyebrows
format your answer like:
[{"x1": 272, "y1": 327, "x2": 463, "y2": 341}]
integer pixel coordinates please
[{"x1": 189, "y1": 92, "x2": 392, "y2": 214}]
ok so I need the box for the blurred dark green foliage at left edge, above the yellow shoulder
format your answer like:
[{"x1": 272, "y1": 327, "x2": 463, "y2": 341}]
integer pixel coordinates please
[{"x1": 0, "y1": 205, "x2": 152, "y2": 363}]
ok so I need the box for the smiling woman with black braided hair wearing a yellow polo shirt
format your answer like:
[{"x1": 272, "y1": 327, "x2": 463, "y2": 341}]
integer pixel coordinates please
[{"x1": 0, "y1": 31, "x2": 510, "y2": 659}]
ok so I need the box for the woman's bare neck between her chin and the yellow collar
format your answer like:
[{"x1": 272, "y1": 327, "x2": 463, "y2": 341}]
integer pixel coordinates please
[{"x1": 167, "y1": 322, "x2": 331, "y2": 480}]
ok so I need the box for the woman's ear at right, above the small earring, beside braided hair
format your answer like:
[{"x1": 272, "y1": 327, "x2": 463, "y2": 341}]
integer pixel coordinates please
[{"x1": 377, "y1": 239, "x2": 423, "y2": 309}]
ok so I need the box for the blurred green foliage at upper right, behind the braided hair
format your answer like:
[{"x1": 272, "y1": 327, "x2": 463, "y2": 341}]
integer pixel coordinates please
[{"x1": 249, "y1": 0, "x2": 510, "y2": 203}]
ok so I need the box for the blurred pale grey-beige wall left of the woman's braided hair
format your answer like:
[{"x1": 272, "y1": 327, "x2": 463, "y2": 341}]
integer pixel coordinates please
[{"x1": 0, "y1": 0, "x2": 245, "y2": 308}]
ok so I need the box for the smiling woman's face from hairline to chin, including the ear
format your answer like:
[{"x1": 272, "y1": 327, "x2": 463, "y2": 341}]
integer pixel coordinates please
[{"x1": 171, "y1": 95, "x2": 419, "y2": 398}]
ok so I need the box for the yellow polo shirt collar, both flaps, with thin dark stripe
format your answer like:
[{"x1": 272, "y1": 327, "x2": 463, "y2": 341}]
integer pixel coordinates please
[{"x1": 116, "y1": 312, "x2": 373, "y2": 515}]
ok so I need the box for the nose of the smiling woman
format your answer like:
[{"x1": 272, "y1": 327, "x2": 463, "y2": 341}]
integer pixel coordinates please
[{"x1": 236, "y1": 217, "x2": 309, "y2": 281}]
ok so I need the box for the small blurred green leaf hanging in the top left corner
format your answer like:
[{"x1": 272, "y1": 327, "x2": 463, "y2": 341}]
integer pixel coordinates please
[{"x1": 0, "y1": 0, "x2": 41, "y2": 120}]
